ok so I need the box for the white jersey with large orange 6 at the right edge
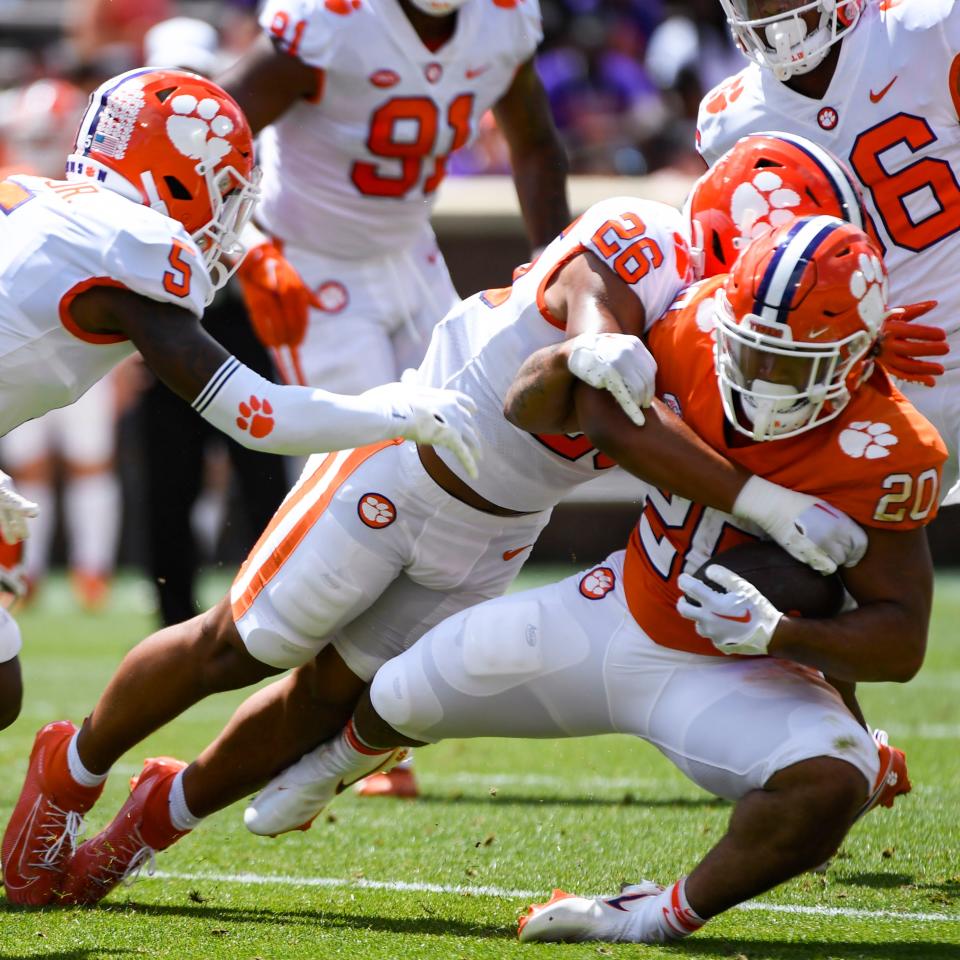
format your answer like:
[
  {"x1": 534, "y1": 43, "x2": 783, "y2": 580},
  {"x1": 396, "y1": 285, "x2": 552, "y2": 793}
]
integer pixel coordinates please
[{"x1": 697, "y1": 0, "x2": 960, "y2": 366}]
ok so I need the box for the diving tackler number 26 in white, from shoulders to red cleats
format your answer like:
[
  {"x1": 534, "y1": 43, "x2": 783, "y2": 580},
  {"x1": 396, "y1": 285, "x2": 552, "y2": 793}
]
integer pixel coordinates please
[{"x1": 4, "y1": 137, "x2": 876, "y2": 903}]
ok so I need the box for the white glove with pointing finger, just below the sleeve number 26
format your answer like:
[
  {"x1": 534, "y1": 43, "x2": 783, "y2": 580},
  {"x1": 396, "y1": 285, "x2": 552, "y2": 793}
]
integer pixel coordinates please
[{"x1": 567, "y1": 333, "x2": 657, "y2": 427}]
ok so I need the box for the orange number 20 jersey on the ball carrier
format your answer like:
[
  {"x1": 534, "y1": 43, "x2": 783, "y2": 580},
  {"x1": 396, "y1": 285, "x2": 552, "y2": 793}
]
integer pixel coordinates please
[{"x1": 624, "y1": 276, "x2": 947, "y2": 656}]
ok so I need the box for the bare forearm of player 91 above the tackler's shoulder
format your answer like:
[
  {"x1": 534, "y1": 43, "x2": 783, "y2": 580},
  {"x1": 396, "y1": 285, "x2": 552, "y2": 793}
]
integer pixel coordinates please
[{"x1": 511, "y1": 145, "x2": 572, "y2": 251}]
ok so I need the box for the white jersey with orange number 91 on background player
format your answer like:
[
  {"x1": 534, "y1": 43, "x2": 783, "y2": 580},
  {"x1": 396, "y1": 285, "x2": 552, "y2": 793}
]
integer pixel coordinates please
[{"x1": 257, "y1": 0, "x2": 542, "y2": 260}]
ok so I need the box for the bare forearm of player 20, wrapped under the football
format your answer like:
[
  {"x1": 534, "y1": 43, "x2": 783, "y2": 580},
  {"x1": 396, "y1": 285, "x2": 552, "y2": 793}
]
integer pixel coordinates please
[{"x1": 768, "y1": 601, "x2": 928, "y2": 683}]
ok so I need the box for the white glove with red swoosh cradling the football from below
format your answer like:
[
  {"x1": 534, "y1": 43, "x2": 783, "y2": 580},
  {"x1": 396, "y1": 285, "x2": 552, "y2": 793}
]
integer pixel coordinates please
[{"x1": 677, "y1": 563, "x2": 783, "y2": 656}]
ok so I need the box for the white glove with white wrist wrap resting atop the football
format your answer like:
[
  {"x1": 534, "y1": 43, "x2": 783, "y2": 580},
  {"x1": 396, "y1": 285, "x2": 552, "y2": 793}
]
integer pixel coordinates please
[{"x1": 733, "y1": 477, "x2": 867, "y2": 575}]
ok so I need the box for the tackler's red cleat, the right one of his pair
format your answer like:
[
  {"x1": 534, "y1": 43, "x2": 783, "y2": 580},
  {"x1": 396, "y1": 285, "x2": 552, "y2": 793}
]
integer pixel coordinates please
[{"x1": 60, "y1": 757, "x2": 189, "y2": 906}]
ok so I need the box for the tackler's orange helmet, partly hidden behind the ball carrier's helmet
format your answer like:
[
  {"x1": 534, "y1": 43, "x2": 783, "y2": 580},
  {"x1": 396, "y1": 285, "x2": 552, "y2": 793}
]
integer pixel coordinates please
[{"x1": 685, "y1": 133, "x2": 868, "y2": 277}]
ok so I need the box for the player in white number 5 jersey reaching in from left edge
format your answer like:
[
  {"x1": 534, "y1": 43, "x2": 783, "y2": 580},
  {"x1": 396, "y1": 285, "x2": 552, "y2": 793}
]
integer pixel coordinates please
[{"x1": 0, "y1": 70, "x2": 484, "y2": 725}]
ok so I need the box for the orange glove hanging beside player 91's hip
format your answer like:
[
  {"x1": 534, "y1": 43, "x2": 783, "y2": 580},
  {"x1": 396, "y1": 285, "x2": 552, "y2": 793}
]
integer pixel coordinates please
[{"x1": 237, "y1": 241, "x2": 320, "y2": 383}]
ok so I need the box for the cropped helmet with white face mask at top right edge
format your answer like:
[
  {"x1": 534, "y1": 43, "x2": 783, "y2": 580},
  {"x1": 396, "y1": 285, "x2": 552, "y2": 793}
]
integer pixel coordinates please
[{"x1": 720, "y1": 0, "x2": 865, "y2": 81}]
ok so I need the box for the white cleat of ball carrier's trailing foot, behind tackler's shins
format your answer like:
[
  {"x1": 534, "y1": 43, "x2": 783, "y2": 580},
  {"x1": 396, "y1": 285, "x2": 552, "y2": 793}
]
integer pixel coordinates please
[{"x1": 243, "y1": 744, "x2": 407, "y2": 837}]
